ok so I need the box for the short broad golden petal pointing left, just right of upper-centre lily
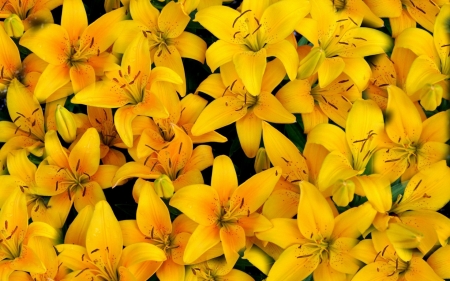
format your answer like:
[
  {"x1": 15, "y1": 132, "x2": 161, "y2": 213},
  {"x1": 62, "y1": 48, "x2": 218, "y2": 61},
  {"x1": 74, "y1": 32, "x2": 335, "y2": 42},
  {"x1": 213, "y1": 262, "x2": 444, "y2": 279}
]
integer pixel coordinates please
[{"x1": 275, "y1": 79, "x2": 314, "y2": 113}]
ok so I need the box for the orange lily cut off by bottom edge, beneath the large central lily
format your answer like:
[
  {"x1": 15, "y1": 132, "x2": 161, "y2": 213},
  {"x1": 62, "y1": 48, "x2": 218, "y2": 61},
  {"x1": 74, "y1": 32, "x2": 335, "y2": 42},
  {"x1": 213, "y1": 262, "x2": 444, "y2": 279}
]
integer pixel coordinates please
[{"x1": 184, "y1": 257, "x2": 254, "y2": 281}]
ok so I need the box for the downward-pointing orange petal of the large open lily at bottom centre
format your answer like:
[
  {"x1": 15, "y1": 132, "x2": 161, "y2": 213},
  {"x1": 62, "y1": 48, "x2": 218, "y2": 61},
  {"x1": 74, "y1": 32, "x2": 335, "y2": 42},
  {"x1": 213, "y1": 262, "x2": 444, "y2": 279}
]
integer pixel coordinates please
[{"x1": 220, "y1": 224, "x2": 245, "y2": 264}]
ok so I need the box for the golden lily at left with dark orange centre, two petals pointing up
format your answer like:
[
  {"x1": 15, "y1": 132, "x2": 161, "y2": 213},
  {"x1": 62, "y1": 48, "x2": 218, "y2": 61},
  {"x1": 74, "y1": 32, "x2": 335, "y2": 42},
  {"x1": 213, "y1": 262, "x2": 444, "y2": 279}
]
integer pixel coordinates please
[{"x1": 36, "y1": 128, "x2": 118, "y2": 211}]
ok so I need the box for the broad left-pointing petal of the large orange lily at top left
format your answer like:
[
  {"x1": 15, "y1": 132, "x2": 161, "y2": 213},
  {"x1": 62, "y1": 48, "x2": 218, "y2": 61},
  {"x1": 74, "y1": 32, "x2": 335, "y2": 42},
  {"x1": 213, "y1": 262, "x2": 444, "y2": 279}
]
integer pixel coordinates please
[{"x1": 20, "y1": 24, "x2": 70, "y2": 65}]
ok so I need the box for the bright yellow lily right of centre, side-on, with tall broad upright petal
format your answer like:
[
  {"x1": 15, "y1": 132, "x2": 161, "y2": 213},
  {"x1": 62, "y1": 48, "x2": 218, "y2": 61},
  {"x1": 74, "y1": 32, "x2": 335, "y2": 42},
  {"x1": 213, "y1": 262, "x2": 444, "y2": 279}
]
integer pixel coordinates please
[{"x1": 308, "y1": 100, "x2": 389, "y2": 206}]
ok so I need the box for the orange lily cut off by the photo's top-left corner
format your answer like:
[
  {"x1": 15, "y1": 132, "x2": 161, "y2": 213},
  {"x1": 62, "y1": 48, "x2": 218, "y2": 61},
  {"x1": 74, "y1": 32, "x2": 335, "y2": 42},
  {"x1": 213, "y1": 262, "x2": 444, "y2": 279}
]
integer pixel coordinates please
[{"x1": 0, "y1": 0, "x2": 63, "y2": 38}]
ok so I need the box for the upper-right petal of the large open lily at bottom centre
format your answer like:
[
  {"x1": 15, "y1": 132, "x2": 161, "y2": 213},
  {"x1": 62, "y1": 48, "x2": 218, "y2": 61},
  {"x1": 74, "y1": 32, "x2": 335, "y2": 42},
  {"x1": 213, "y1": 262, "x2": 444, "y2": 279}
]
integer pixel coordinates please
[{"x1": 230, "y1": 167, "x2": 281, "y2": 216}]
